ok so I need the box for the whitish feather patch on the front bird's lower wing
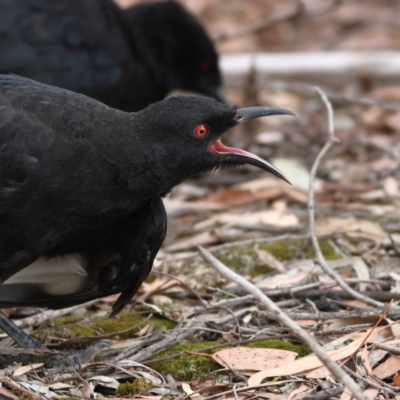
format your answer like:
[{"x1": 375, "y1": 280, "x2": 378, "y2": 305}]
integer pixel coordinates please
[{"x1": 3, "y1": 253, "x2": 89, "y2": 296}]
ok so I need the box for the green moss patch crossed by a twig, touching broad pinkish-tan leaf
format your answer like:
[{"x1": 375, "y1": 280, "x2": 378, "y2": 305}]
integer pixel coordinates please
[{"x1": 151, "y1": 342, "x2": 221, "y2": 381}]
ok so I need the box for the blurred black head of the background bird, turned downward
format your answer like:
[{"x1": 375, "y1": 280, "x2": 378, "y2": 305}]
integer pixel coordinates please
[{"x1": 124, "y1": 1, "x2": 226, "y2": 102}]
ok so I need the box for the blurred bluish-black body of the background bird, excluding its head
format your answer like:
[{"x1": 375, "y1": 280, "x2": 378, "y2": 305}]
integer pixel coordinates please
[{"x1": 0, "y1": 0, "x2": 132, "y2": 108}]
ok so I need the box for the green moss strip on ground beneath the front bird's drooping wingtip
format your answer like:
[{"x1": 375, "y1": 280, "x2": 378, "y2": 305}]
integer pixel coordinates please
[{"x1": 55, "y1": 314, "x2": 175, "y2": 340}]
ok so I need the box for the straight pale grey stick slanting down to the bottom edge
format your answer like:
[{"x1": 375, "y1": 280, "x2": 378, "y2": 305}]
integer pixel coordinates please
[{"x1": 198, "y1": 246, "x2": 366, "y2": 400}]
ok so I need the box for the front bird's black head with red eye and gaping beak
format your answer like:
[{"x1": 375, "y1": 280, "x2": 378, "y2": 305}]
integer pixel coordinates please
[{"x1": 133, "y1": 96, "x2": 295, "y2": 191}]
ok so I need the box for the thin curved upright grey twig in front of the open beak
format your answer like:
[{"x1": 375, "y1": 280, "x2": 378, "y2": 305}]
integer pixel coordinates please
[{"x1": 308, "y1": 86, "x2": 385, "y2": 307}]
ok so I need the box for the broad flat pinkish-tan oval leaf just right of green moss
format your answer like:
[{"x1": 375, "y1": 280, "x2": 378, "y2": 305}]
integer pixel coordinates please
[{"x1": 211, "y1": 347, "x2": 298, "y2": 371}]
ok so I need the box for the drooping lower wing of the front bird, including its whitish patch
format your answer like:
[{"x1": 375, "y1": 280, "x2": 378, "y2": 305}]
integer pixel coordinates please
[{"x1": 0, "y1": 196, "x2": 167, "y2": 315}]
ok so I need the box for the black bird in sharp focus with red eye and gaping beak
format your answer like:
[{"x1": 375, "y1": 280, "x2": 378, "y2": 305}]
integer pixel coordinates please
[{"x1": 0, "y1": 75, "x2": 293, "y2": 366}]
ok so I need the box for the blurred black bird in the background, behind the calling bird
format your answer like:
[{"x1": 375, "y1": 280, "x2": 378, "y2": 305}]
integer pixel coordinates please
[{"x1": 0, "y1": 0, "x2": 224, "y2": 111}]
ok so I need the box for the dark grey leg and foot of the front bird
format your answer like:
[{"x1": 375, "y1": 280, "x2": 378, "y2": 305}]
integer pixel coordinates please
[{"x1": 0, "y1": 311, "x2": 104, "y2": 368}]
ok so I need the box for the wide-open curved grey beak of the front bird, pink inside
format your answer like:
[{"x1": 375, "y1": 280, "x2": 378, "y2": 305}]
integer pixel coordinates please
[{"x1": 211, "y1": 107, "x2": 296, "y2": 184}]
